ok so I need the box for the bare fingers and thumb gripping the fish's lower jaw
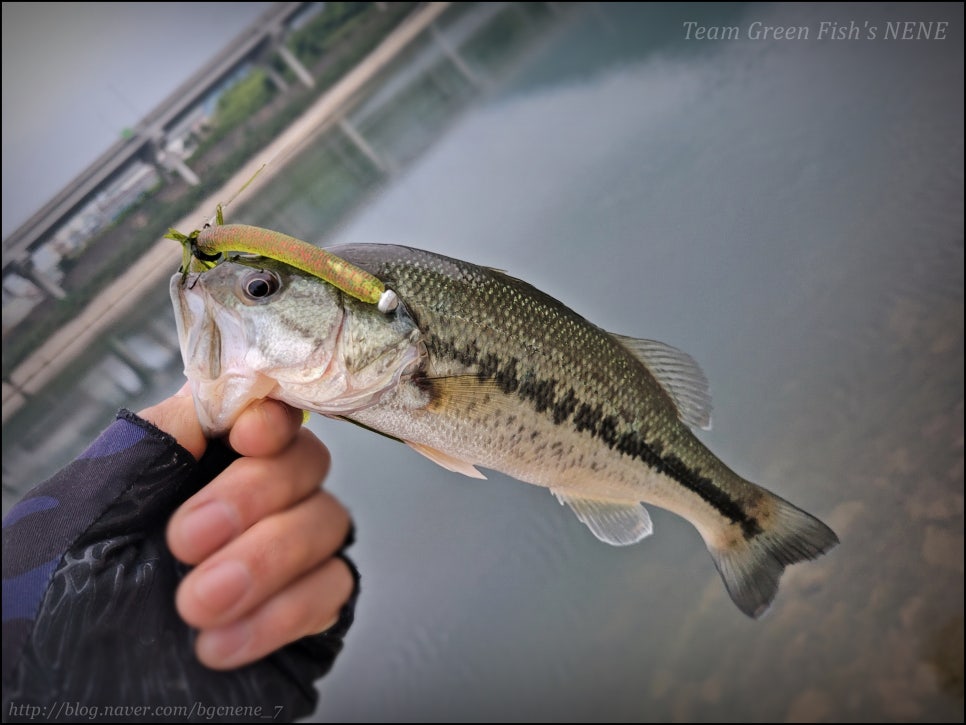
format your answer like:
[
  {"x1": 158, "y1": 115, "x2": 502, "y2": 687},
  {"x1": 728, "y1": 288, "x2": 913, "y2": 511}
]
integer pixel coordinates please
[{"x1": 139, "y1": 389, "x2": 354, "y2": 669}]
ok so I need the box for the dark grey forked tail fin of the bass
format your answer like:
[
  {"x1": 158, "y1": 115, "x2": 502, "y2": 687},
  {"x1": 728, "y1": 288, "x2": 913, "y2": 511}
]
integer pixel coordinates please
[{"x1": 708, "y1": 492, "x2": 839, "y2": 619}]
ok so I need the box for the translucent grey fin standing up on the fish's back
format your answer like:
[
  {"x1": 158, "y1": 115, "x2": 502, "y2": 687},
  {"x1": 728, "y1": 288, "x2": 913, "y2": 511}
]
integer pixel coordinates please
[{"x1": 611, "y1": 333, "x2": 711, "y2": 430}]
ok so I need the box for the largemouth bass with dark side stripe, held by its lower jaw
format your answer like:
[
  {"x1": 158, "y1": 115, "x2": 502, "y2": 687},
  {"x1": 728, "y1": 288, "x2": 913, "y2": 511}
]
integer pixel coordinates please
[{"x1": 170, "y1": 244, "x2": 839, "y2": 618}]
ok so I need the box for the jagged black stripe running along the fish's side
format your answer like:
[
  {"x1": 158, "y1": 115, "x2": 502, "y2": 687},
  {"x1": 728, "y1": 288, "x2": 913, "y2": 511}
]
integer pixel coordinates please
[{"x1": 427, "y1": 335, "x2": 762, "y2": 539}]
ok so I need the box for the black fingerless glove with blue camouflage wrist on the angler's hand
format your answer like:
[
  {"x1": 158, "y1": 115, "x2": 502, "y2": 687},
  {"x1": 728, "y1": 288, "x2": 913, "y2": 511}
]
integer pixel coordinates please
[{"x1": 3, "y1": 411, "x2": 358, "y2": 722}]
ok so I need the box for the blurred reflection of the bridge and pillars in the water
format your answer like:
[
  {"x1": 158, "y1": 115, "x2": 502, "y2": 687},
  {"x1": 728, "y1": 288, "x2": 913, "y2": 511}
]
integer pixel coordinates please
[{"x1": 3, "y1": 3, "x2": 570, "y2": 504}]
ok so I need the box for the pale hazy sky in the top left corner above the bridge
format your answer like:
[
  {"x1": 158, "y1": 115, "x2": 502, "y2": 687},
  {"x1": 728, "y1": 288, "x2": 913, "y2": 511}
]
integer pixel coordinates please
[{"x1": 3, "y1": 2, "x2": 271, "y2": 238}]
